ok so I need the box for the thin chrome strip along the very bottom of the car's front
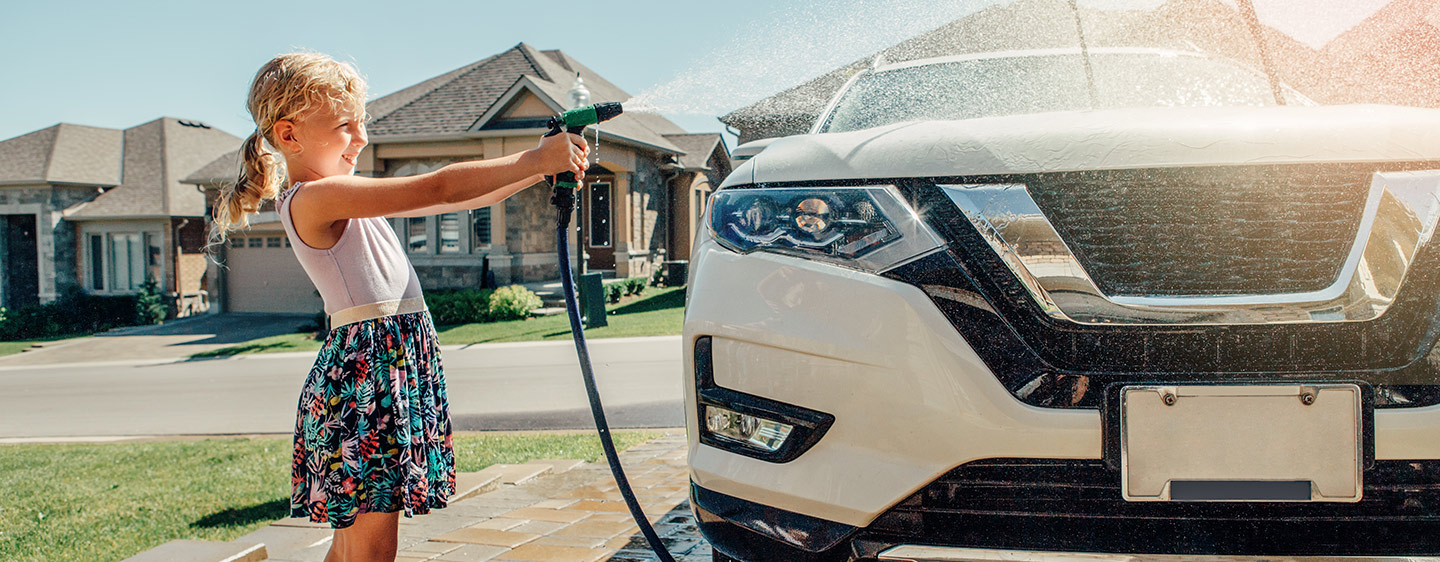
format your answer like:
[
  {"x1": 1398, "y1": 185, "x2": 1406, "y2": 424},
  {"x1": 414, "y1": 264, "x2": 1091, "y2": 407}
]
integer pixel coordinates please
[{"x1": 880, "y1": 545, "x2": 1440, "y2": 562}]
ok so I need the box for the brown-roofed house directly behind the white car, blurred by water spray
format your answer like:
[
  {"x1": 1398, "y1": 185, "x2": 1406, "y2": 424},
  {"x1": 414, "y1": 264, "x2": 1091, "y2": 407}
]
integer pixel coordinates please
[{"x1": 720, "y1": 0, "x2": 1440, "y2": 143}]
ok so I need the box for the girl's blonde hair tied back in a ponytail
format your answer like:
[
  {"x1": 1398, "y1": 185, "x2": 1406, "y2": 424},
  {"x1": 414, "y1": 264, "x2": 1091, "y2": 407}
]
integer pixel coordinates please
[{"x1": 210, "y1": 52, "x2": 366, "y2": 245}]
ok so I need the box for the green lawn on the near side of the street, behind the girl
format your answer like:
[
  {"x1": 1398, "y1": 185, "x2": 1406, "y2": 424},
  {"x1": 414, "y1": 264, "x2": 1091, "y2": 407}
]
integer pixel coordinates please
[{"x1": 0, "y1": 431, "x2": 660, "y2": 561}]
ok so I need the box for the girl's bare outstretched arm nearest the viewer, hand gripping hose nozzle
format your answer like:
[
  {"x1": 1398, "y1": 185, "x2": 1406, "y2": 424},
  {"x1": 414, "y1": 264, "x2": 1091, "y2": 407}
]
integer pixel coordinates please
[{"x1": 289, "y1": 134, "x2": 588, "y2": 226}]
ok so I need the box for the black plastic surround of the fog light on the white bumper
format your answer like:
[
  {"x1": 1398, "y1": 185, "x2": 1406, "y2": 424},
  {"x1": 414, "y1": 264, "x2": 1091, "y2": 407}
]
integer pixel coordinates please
[{"x1": 696, "y1": 336, "x2": 835, "y2": 464}]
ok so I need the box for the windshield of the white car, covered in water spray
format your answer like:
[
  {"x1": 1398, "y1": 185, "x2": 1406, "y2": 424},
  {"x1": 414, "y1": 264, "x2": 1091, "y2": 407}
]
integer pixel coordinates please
[{"x1": 822, "y1": 53, "x2": 1289, "y2": 133}]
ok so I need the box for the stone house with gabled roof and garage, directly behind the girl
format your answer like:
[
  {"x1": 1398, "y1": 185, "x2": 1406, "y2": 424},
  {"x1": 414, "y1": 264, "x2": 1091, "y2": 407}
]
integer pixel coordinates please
[{"x1": 184, "y1": 43, "x2": 730, "y2": 311}]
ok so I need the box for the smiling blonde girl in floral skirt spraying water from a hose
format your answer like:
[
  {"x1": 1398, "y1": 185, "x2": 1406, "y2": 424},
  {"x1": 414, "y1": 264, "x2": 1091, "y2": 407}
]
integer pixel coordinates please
[{"x1": 212, "y1": 53, "x2": 588, "y2": 562}]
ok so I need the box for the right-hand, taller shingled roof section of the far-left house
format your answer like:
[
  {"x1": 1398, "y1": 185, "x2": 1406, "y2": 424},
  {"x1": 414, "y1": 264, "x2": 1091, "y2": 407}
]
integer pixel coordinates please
[{"x1": 65, "y1": 117, "x2": 240, "y2": 220}]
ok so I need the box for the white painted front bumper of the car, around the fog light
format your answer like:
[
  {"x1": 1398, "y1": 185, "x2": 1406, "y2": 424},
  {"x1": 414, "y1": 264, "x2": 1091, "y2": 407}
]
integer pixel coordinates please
[{"x1": 684, "y1": 239, "x2": 1440, "y2": 556}]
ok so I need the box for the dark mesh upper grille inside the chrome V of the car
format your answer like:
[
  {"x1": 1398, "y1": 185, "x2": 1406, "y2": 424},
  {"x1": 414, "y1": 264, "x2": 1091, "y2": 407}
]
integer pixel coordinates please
[{"x1": 1027, "y1": 166, "x2": 1372, "y2": 295}]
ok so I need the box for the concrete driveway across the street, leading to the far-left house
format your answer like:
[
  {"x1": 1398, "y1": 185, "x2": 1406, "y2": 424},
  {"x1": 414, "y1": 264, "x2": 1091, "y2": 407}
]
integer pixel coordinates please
[{"x1": 0, "y1": 314, "x2": 311, "y2": 367}]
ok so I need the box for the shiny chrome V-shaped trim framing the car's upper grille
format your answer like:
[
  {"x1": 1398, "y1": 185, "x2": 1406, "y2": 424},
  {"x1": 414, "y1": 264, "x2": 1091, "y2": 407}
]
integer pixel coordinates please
[{"x1": 940, "y1": 170, "x2": 1440, "y2": 324}]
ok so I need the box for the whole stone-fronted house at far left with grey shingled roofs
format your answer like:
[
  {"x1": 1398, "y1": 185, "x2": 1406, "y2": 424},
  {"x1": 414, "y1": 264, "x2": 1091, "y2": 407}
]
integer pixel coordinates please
[{"x1": 0, "y1": 117, "x2": 240, "y2": 316}]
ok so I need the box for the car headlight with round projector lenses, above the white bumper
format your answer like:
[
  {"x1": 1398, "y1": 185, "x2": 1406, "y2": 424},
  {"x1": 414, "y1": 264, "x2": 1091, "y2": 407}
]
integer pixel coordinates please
[{"x1": 710, "y1": 186, "x2": 943, "y2": 272}]
